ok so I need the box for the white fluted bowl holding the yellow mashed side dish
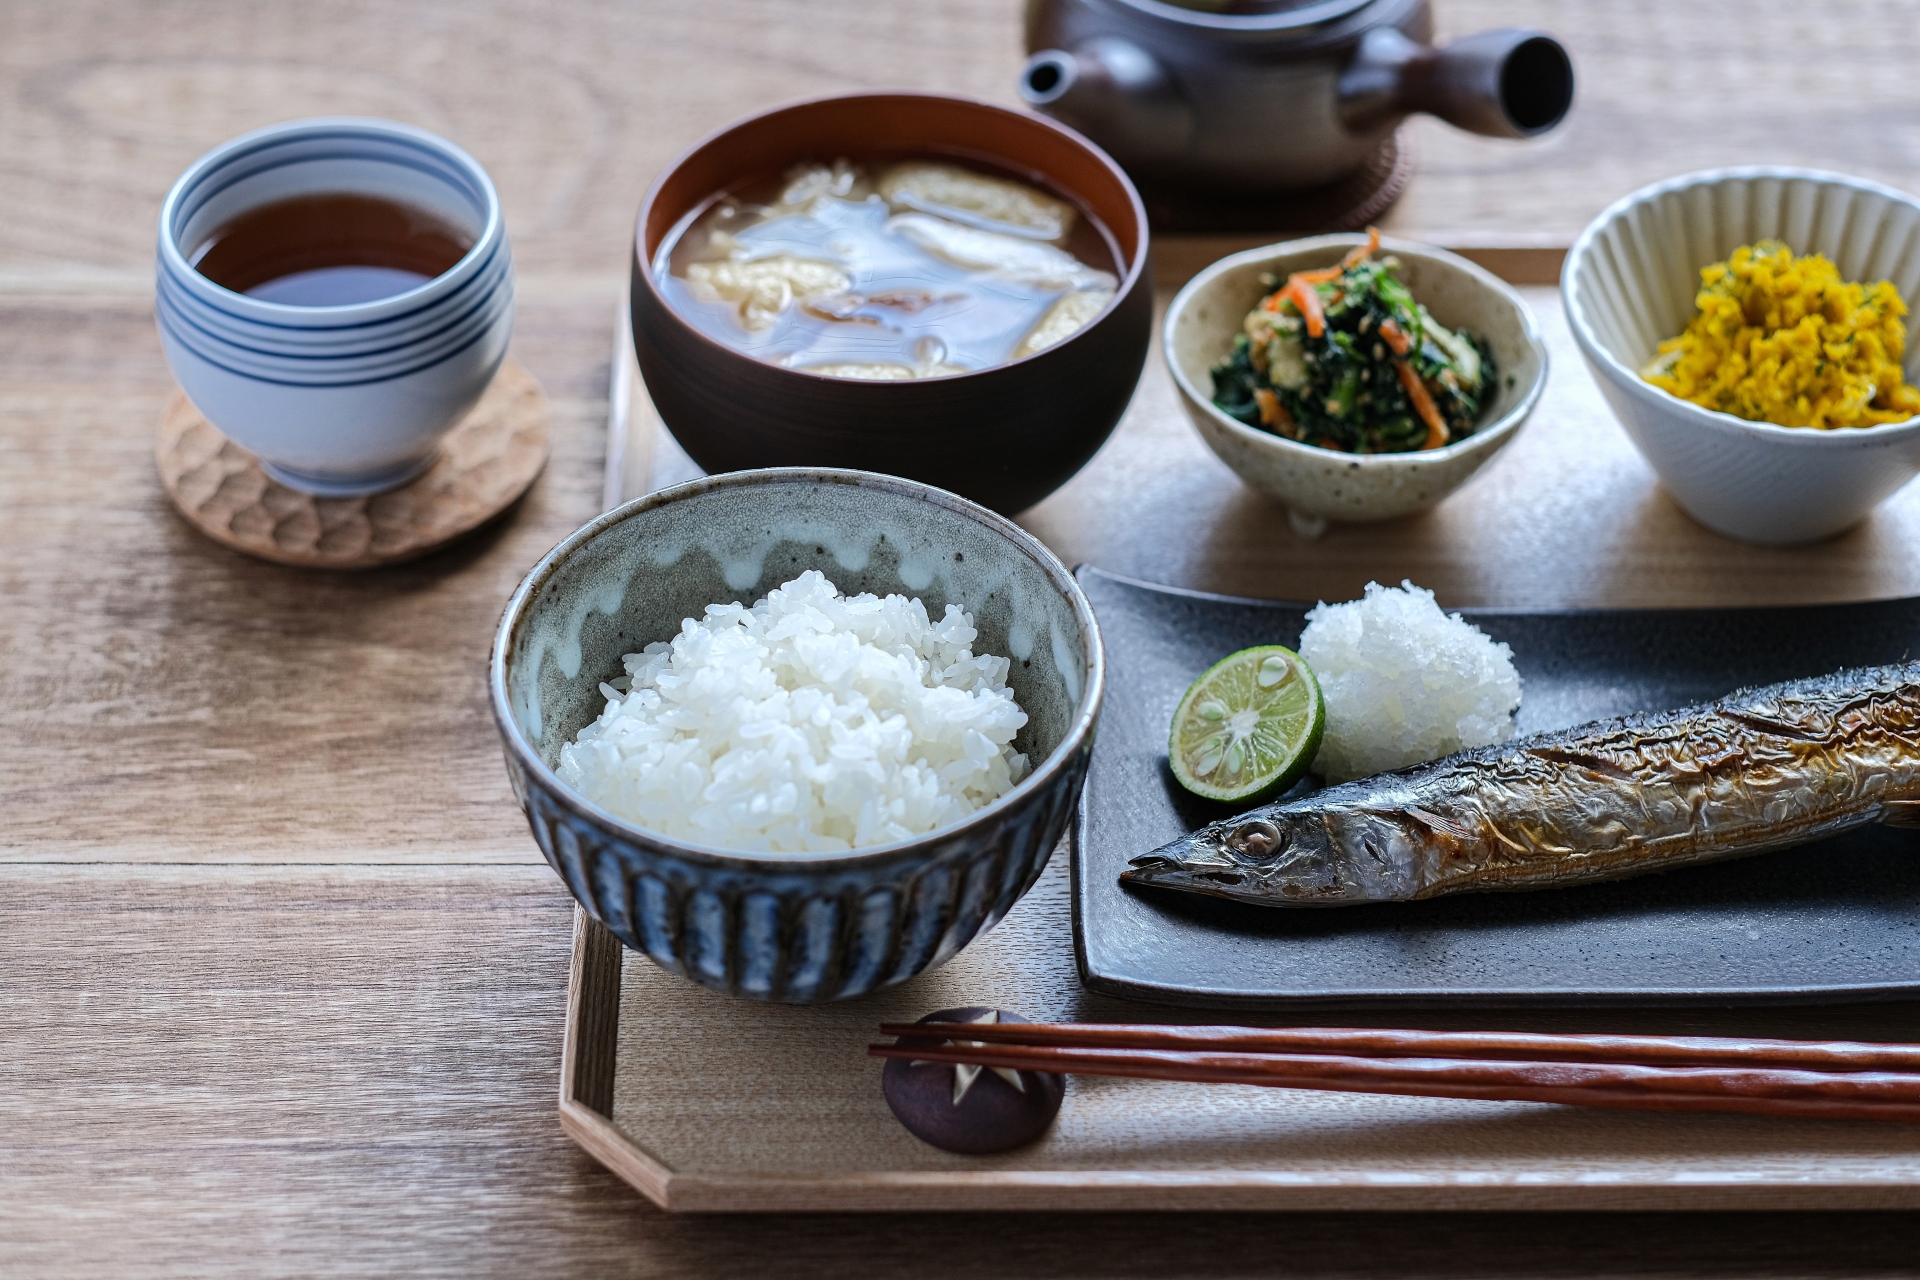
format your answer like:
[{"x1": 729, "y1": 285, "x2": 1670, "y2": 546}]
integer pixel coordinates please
[{"x1": 1561, "y1": 169, "x2": 1920, "y2": 545}]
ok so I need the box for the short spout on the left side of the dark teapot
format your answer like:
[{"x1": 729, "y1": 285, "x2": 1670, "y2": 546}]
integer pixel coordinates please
[{"x1": 1020, "y1": 36, "x2": 1194, "y2": 169}]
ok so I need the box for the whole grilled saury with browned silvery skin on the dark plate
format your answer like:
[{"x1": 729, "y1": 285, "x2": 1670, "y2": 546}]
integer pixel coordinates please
[{"x1": 1121, "y1": 662, "x2": 1920, "y2": 906}]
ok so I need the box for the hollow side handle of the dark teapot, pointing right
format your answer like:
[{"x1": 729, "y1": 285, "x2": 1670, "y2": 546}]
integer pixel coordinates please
[{"x1": 1336, "y1": 27, "x2": 1572, "y2": 138}]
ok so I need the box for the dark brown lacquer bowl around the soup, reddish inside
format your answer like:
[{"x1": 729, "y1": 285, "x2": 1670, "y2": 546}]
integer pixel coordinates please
[{"x1": 632, "y1": 94, "x2": 1154, "y2": 512}]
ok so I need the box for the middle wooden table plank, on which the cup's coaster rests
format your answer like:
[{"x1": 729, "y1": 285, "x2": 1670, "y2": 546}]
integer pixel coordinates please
[{"x1": 0, "y1": 292, "x2": 612, "y2": 862}]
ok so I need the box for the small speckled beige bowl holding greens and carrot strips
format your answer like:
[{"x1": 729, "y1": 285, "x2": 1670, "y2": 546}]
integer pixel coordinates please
[{"x1": 1162, "y1": 234, "x2": 1548, "y2": 526}]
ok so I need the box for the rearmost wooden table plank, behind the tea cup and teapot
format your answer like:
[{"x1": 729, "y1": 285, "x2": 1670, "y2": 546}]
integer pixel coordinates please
[{"x1": 0, "y1": 0, "x2": 1920, "y2": 271}]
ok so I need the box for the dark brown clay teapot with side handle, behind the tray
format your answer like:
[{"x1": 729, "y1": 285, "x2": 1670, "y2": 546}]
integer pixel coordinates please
[{"x1": 1020, "y1": 0, "x2": 1572, "y2": 196}]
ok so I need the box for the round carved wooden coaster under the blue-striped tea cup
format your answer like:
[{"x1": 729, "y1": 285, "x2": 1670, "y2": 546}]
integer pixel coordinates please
[{"x1": 154, "y1": 359, "x2": 553, "y2": 568}]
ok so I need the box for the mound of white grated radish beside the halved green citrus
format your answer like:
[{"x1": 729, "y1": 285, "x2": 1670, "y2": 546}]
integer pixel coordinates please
[{"x1": 1300, "y1": 581, "x2": 1521, "y2": 781}]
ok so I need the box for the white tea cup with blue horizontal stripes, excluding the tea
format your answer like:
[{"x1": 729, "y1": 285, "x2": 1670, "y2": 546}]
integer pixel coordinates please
[{"x1": 156, "y1": 117, "x2": 513, "y2": 495}]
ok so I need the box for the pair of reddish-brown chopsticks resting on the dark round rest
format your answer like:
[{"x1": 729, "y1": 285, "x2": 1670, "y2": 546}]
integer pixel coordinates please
[{"x1": 868, "y1": 1023, "x2": 1920, "y2": 1123}]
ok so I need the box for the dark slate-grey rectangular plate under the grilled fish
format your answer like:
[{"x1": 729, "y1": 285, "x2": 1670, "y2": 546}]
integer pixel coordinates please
[{"x1": 1073, "y1": 566, "x2": 1920, "y2": 1009}]
